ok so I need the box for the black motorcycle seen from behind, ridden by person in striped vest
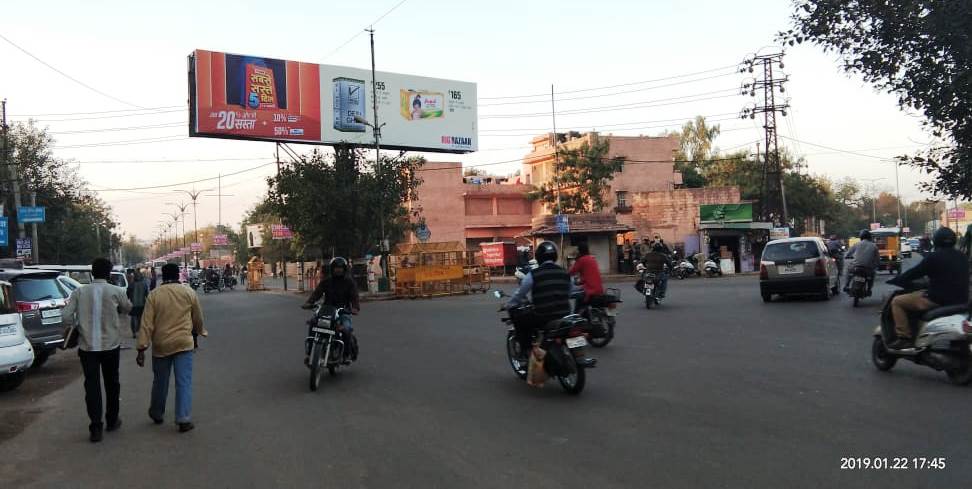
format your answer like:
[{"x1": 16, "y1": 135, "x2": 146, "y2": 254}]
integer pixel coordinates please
[{"x1": 493, "y1": 290, "x2": 593, "y2": 395}]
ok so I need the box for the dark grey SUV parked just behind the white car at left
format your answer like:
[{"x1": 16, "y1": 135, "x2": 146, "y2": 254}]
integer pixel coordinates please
[{"x1": 0, "y1": 268, "x2": 69, "y2": 366}]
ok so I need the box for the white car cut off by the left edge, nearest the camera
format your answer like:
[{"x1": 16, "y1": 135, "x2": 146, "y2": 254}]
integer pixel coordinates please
[{"x1": 0, "y1": 281, "x2": 34, "y2": 391}]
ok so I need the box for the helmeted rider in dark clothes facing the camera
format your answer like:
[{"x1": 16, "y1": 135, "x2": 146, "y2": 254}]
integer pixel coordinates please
[{"x1": 301, "y1": 256, "x2": 361, "y2": 364}]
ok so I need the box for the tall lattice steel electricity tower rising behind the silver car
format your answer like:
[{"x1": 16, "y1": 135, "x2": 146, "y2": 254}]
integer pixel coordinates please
[{"x1": 739, "y1": 52, "x2": 790, "y2": 226}]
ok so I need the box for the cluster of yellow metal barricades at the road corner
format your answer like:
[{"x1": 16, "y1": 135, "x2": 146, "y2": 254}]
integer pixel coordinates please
[{"x1": 389, "y1": 241, "x2": 489, "y2": 298}]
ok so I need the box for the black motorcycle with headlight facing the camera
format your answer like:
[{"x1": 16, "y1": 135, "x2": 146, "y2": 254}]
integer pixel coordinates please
[{"x1": 301, "y1": 304, "x2": 354, "y2": 391}]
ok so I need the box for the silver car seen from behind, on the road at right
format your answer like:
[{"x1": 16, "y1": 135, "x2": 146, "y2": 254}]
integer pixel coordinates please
[{"x1": 759, "y1": 238, "x2": 840, "y2": 302}]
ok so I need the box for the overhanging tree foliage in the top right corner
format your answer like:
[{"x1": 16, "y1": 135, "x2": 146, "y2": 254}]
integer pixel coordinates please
[{"x1": 780, "y1": 0, "x2": 972, "y2": 199}]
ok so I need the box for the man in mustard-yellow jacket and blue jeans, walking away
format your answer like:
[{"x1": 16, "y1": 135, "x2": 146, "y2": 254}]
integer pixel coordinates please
[{"x1": 135, "y1": 263, "x2": 208, "y2": 433}]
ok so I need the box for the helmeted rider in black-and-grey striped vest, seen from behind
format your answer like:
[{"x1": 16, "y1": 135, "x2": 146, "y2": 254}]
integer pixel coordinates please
[{"x1": 505, "y1": 241, "x2": 595, "y2": 366}]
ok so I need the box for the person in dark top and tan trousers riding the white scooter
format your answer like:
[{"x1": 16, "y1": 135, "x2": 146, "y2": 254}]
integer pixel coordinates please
[{"x1": 888, "y1": 227, "x2": 969, "y2": 350}]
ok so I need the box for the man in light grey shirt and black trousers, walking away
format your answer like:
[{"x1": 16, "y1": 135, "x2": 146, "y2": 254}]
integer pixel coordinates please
[{"x1": 62, "y1": 258, "x2": 132, "y2": 443}]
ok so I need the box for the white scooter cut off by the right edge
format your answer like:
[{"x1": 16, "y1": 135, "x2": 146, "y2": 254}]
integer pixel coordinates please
[{"x1": 871, "y1": 289, "x2": 972, "y2": 385}]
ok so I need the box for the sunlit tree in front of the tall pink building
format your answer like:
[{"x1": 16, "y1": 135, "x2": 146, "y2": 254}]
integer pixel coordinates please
[{"x1": 529, "y1": 135, "x2": 624, "y2": 214}]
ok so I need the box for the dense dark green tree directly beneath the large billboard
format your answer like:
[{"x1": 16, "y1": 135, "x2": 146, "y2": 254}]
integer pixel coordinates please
[{"x1": 266, "y1": 146, "x2": 425, "y2": 257}]
